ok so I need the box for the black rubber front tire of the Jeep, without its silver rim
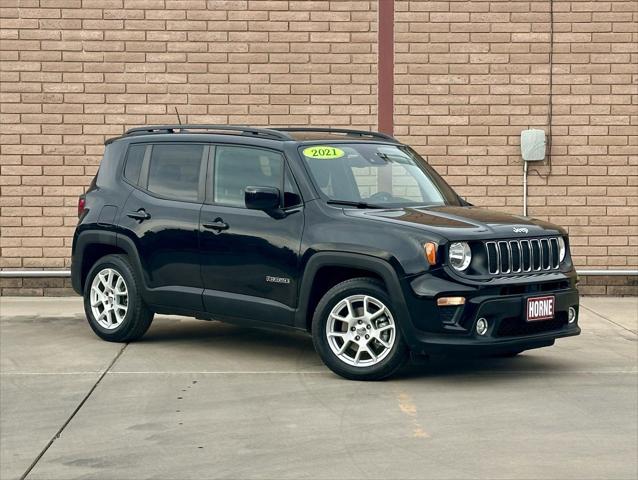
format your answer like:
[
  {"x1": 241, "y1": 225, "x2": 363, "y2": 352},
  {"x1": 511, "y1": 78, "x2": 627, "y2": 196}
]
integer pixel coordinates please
[{"x1": 312, "y1": 278, "x2": 409, "y2": 380}]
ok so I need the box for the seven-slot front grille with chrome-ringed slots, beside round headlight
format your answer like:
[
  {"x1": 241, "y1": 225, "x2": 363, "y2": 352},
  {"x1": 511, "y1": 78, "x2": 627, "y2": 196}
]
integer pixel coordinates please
[{"x1": 485, "y1": 237, "x2": 560, "y2": 275}]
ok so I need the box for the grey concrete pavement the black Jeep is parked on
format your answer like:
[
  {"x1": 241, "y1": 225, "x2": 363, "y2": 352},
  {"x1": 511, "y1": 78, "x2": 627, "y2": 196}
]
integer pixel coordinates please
[{"x1": 0, "y1": 297, "x2": 638, "y2": 479}]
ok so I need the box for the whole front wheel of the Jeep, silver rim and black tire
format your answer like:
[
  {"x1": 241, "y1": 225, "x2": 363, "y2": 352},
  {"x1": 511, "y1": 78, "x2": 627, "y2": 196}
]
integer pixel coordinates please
[{"x1": 312, "y1": 278, "x2": 408, "y2": 380}]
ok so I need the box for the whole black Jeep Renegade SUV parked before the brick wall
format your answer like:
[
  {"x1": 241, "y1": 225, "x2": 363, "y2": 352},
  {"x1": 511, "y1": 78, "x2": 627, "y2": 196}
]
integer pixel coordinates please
[{"x1": 72, "y1": 125, "x2": 580, "y2": 379}]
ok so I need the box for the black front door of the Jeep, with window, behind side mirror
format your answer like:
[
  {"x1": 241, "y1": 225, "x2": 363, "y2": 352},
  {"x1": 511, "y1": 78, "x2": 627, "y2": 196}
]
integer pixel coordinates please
[{"x1": 200, "y1": 146, "x2": 304, "y2": 324}]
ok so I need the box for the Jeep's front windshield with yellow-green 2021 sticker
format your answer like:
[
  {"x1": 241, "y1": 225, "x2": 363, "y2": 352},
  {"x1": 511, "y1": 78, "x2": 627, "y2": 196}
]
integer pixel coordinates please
[{"x1": 300, "y1": 143, "x2": 460, "y2": 207}]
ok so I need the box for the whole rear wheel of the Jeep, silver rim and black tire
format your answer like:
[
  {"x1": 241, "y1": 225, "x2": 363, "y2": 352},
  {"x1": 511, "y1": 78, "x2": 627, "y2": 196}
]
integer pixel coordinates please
[{"x1": 84, "y1": 255, "x2": 153, "y2": 342}]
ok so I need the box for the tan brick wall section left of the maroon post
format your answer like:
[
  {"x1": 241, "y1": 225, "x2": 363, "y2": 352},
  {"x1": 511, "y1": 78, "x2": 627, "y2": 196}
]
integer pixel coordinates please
[{"x1": 0, "y1": 0, "x2": 376, "y2": 286}]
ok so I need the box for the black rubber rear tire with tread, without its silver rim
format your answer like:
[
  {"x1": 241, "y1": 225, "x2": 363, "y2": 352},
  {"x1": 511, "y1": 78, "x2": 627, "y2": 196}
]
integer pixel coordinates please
[{"x1": 84, "y1": 255, "x2": 153, "y2": 342}]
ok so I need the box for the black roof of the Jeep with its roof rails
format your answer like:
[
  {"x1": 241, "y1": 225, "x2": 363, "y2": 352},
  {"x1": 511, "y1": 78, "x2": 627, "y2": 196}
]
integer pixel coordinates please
[{"x1": 106, "y1": 124, "x2": 397, "y2": 143}]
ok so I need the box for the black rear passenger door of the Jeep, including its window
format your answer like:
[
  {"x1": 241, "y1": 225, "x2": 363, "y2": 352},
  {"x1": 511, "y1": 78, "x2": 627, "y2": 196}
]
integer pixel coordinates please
[{"x1": 119, "y1": 144, "x2": 208, "y2": 311}]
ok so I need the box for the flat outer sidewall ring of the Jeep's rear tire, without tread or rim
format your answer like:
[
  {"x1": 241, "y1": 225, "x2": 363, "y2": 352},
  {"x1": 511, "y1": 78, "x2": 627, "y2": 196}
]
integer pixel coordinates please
[{"x1": 84, "y1": 255, "x2": 140, "y2": 340}]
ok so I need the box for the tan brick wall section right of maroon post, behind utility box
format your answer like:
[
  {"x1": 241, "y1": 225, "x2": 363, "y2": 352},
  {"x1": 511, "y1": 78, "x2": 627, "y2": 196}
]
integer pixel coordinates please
[{"x1": 395, "y1": 0, "x2": 638, "y2": 269}]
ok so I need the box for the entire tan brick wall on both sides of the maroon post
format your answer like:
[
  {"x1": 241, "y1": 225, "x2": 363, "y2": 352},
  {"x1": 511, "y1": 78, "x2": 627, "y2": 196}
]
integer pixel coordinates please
[{"x1": 0, "y1": 0, "x2": 638, "y2": 294}]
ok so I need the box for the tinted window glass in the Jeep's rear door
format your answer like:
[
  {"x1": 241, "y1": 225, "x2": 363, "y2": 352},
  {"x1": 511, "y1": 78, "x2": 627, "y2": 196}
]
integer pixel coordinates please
[{"x1": 146, "y1": 144, "x2": 204, "y2": 202}]
